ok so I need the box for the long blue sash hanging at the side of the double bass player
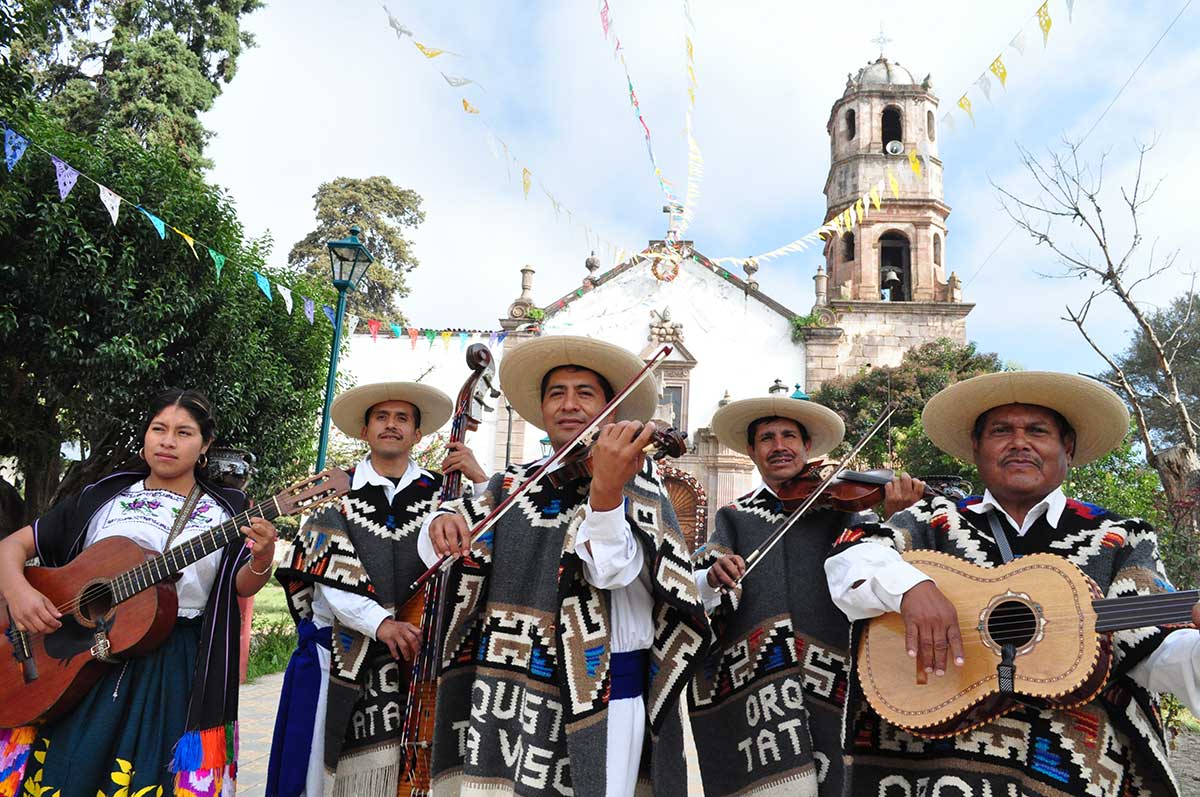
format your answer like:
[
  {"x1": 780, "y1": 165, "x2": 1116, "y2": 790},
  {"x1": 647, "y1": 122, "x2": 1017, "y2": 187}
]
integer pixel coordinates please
[{"x1": 266, "y1": 619, "x2": 332, "y2": 797}]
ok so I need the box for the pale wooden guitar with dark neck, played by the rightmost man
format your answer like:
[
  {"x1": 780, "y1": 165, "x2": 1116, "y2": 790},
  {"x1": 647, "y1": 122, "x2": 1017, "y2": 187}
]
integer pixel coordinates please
[{"x1": 858, "y1": 551, "x2": 1200, "y2": 738}]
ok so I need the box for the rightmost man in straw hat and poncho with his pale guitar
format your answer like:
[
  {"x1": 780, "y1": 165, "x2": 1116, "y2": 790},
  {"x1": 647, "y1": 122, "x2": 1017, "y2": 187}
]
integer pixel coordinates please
[{"x1": 826, "y1": 372, "x2": 1200, "y2": 797}]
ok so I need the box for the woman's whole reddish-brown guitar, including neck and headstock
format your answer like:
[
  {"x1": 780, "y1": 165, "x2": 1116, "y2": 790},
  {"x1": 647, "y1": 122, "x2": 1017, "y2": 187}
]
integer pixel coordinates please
[{"x1": 0, "y1": 469, "x2": 350, "y2": 727}]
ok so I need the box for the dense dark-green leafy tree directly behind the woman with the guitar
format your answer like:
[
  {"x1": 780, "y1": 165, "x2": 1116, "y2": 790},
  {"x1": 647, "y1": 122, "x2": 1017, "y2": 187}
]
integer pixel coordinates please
[{"x1": 0, "y1": 102, "x2": 332, "y2": 516}]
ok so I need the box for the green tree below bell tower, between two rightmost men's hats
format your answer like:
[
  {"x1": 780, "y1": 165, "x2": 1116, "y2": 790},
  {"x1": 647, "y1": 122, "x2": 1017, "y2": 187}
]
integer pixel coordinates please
[{"x1": 812, "y1": 337, "x2": 1002, "y2": 478}]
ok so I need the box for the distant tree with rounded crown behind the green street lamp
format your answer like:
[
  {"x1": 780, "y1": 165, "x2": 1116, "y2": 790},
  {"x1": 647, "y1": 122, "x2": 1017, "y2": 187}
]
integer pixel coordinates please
[{"x1": 288, "y1": 176, "x2": 425, "y2": 324}]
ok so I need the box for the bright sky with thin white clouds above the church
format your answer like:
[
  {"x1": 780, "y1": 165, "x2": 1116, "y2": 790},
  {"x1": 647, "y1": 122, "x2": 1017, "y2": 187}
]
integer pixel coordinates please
[{"x1": 203, "y1": 0, "x2": 1200, "y2": 373}]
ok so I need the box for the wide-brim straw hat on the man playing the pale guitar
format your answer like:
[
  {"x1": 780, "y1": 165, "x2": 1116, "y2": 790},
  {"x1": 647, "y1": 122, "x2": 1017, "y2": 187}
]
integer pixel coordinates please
[{"x1": 920, "y1": 371, "x2": 1129, "y2": 466}]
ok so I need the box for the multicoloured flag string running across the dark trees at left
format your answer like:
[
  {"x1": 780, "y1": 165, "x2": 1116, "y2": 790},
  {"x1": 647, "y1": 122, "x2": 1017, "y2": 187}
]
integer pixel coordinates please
[{"x1": 0, "y1": 115, "x2": 508, "y2": 348}]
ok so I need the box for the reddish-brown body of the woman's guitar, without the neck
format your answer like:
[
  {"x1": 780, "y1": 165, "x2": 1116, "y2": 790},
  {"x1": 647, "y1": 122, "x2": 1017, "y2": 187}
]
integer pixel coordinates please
[{"x1": 0, "y1": 537, "x2": 179, "y2": 727}]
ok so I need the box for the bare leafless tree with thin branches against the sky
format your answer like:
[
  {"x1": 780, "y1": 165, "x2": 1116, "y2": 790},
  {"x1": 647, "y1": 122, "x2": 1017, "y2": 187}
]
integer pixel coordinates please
[{"x1": 996, "y1": 140, "x2": 1200, "y2": 534}]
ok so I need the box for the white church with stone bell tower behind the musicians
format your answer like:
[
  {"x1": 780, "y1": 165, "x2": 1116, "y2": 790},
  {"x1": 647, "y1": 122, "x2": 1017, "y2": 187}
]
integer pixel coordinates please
[{"x1": 346, "y1": 56, "x2": 972, "y2": 543}]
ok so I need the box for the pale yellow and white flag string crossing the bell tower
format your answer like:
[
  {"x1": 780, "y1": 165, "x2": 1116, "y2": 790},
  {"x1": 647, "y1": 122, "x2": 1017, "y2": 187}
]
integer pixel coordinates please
[{"x1": 714, "y1": 0, "x2": 1075, "y2": 263}]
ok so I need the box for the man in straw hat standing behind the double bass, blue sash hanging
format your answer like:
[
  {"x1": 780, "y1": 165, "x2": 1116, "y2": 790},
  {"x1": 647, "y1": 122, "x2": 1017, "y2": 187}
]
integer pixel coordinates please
[{"x1": 266, "y1": 382, "x2": 486, "y2": 797}]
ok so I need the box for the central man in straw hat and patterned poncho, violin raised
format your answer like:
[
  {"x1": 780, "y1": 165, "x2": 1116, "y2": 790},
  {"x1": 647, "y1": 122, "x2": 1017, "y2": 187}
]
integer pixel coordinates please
[{"x1": 421, "y1": 335, "x2": 708, "y2": 797}]
